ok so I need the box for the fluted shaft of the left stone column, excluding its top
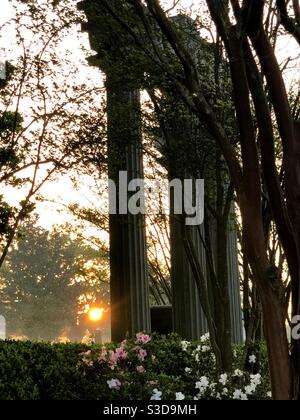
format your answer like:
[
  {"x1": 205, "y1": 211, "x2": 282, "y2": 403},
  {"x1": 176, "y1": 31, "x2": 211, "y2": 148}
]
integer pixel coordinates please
[{"x1": 107, "y1": 79, "x2": 151, "y2": 341}]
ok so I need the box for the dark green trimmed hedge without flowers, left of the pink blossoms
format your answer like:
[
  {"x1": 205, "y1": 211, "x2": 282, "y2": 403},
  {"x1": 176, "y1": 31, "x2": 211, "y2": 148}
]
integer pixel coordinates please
[{"x1": 0, "y1": 341, "x2": 96, "y2": 400}]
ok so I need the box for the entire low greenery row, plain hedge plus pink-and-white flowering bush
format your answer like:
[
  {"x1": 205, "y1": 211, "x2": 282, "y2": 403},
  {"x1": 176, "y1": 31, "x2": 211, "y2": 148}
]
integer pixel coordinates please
[{"x1": 0, "y1": 333, "x2": 271, "y2": 401}]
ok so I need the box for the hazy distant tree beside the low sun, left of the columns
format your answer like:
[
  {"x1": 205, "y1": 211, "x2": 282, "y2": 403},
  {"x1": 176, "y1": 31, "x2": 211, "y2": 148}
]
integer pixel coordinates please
[{"x1": 0, "y1": 221, "x2": 109, "y2": 340}]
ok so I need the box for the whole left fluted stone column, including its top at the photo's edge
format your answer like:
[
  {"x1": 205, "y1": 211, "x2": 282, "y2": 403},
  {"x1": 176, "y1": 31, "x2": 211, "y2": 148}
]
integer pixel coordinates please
[{"x1": 78, "y1": 0, "x2": 151, "y2": 341}]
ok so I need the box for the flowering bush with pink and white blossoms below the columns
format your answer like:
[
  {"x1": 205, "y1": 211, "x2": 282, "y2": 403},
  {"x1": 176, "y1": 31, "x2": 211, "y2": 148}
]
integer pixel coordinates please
[{"x1": 78, "y1": 333, "x2": 271, "y2": 400}]
